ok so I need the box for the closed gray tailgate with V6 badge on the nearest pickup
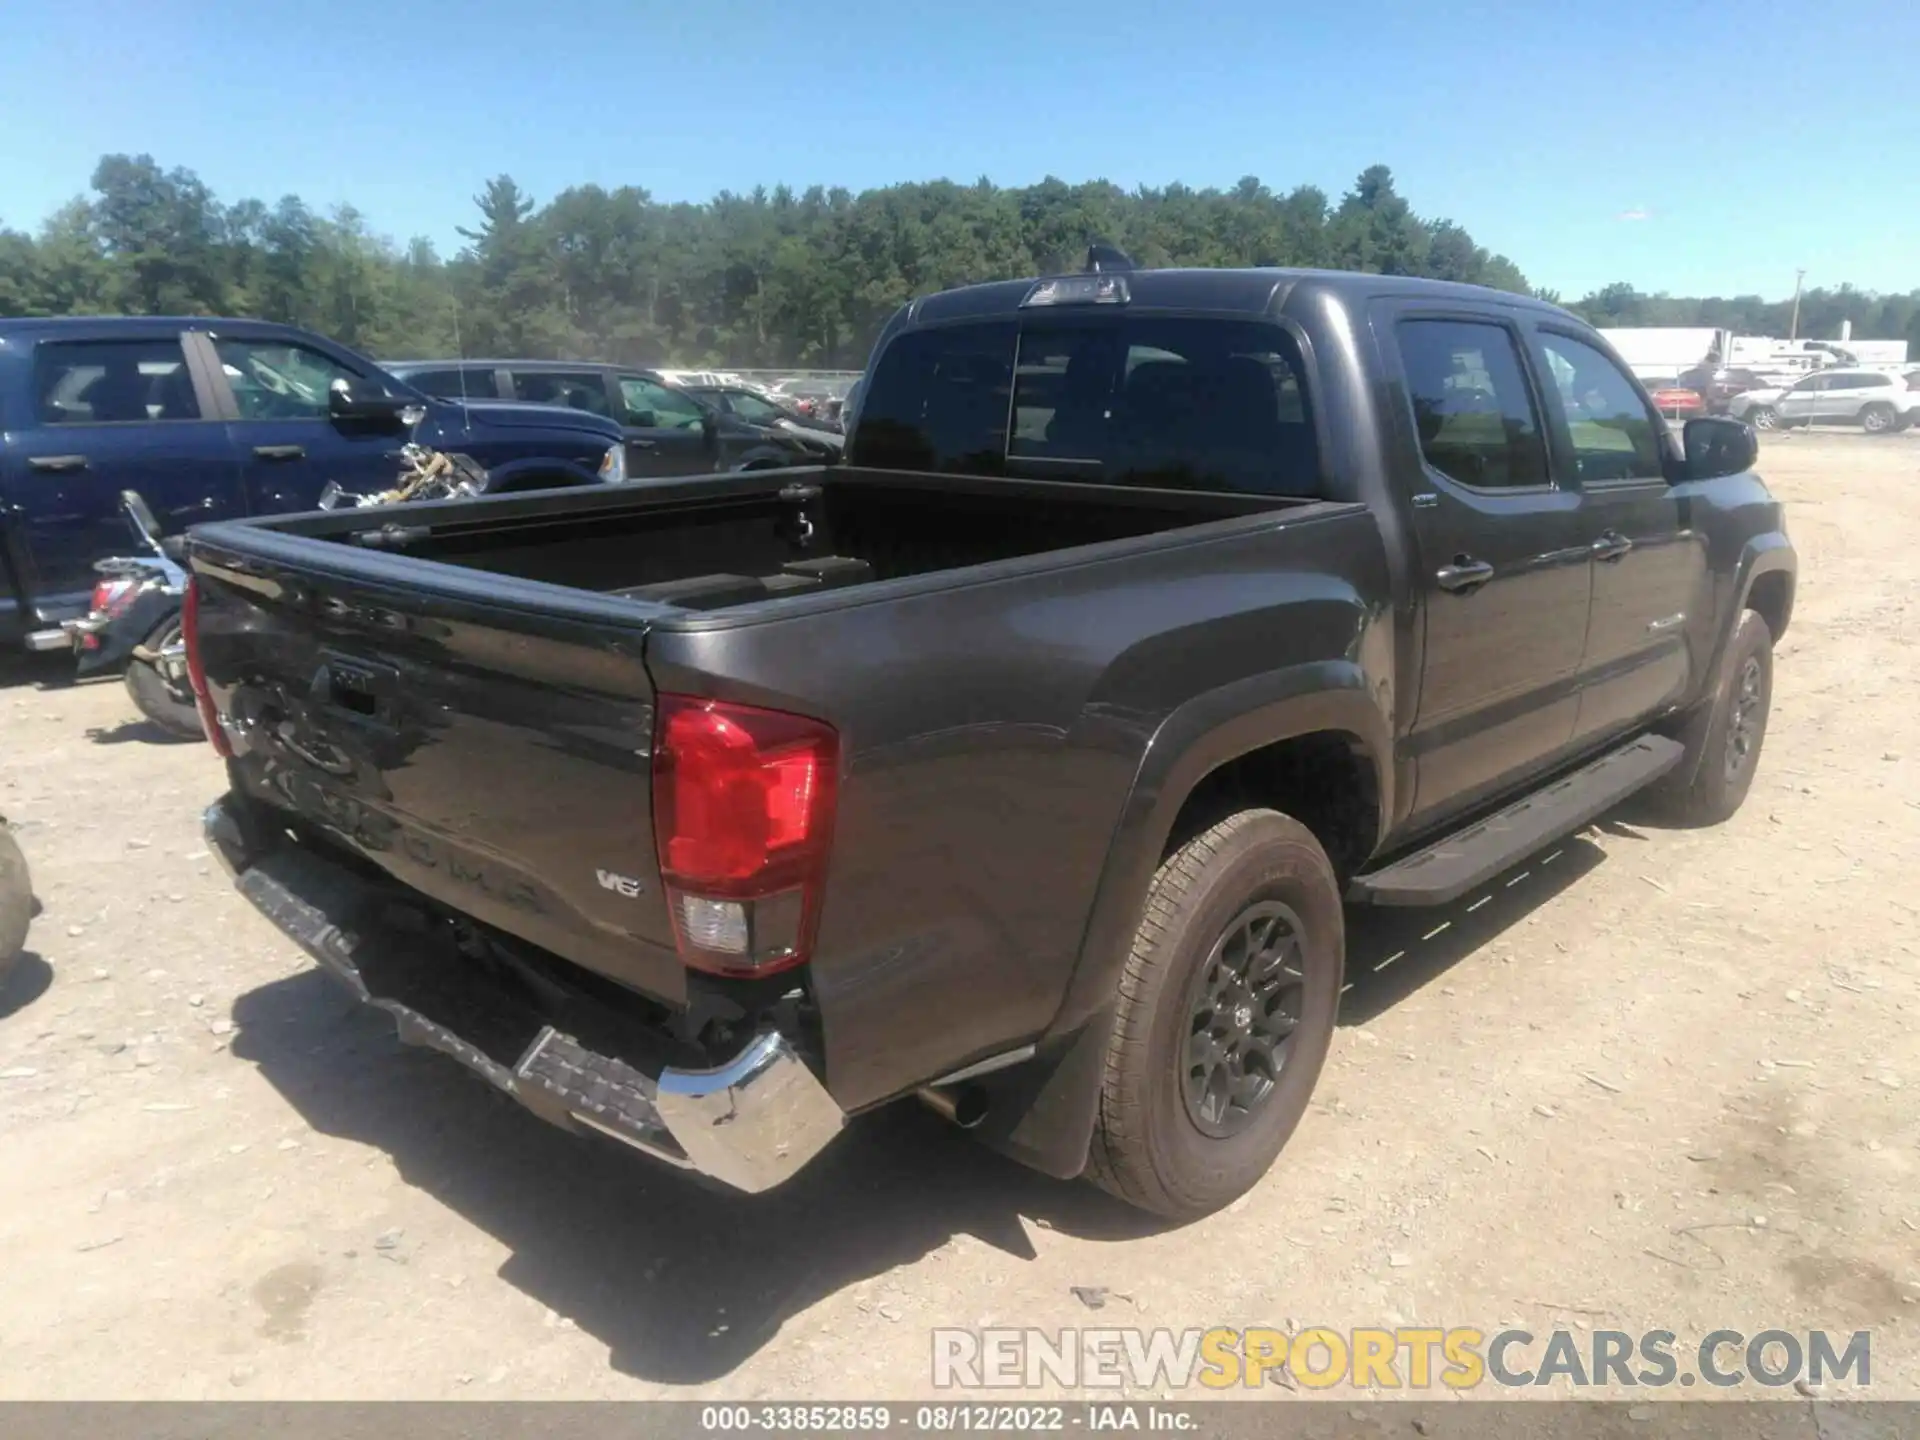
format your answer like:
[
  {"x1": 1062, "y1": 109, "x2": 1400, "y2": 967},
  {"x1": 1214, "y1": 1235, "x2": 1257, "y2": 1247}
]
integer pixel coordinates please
[{"x1": 192, "y1": 526, "x2": 685, "y2": 1004}]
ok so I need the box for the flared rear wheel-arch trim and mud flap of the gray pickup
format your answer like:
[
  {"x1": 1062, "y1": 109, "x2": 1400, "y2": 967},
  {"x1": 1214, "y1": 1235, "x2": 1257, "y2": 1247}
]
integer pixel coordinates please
[{"x1": 975, "y1": 659, "x2": 1394, "y2": 1179}]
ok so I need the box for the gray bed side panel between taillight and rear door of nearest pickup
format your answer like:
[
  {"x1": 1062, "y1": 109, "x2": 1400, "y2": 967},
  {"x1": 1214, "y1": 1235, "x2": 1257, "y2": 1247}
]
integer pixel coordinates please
[{"x1": 647, "y1": 505, "x2": 1392, "y2": 1108}]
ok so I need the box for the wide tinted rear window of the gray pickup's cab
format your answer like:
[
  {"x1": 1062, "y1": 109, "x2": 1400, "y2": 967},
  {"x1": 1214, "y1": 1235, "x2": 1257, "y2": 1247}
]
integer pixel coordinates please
[{"x1": 852, "y1": 315, "x2": 1319, "y2": 495}]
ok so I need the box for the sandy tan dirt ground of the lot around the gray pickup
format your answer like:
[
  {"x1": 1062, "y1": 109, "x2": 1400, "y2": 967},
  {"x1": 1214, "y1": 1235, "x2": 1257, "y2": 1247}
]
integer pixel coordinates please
[{"x1": 0, "y1": 434, "x2": 1920, "y2": 1398}]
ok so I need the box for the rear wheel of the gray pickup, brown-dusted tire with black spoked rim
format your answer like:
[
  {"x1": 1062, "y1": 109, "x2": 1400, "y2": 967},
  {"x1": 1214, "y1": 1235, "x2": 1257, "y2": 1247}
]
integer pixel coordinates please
[{"x1": 1087, "y1": 810, "x2": 1346, "y2": 1219}]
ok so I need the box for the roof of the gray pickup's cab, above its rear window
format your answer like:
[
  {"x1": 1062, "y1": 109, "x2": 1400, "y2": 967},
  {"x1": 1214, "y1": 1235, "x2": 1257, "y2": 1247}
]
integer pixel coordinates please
[{"x1": 908, "y1": 269, "x2": 1563, "y2": 324}]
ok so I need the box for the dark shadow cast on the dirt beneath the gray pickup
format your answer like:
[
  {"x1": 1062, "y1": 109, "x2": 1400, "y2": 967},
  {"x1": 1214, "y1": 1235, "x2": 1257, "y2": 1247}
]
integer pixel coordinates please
[{"x1": 232, "y1": 841, "x2": 1603, "y2": 1384}]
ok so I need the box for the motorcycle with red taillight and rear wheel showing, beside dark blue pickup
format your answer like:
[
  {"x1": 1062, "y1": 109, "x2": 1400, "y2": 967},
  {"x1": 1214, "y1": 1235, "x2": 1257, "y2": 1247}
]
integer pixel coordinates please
[{"x1": 63, "y1": 490, "x2": 205, "y2": 739}]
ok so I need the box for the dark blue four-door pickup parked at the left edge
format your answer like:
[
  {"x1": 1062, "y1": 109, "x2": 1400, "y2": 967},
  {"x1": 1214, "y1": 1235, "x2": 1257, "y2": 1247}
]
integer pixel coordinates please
[{"x1": 0, "y1": 317, "x2": 626, "y2": 649}]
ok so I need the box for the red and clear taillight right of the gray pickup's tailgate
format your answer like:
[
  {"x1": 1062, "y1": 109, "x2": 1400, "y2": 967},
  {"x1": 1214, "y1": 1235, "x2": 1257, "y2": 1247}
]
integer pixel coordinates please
[{"x1": 653, "y1": 695, "x2": 839, "y2": 975}]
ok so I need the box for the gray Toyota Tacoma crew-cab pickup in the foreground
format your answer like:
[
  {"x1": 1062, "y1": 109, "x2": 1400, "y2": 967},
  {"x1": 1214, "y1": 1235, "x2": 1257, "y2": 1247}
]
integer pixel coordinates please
[{"x1": 188, "y1": 259, "x2": 1795, "y2": 1215}]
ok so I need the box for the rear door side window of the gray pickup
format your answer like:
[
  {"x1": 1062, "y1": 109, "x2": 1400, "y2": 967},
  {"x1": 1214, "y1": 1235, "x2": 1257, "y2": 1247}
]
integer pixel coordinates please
[{"x1": 1396, "y1": 321, "x2": 1548, "y2": 490}]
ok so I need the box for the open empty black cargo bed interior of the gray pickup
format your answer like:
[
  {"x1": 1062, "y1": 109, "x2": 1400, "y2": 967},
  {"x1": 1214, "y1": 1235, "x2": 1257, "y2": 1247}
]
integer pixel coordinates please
[{"x1": 217, "y1": 467, "x2": 1309, "y2": 611}]
